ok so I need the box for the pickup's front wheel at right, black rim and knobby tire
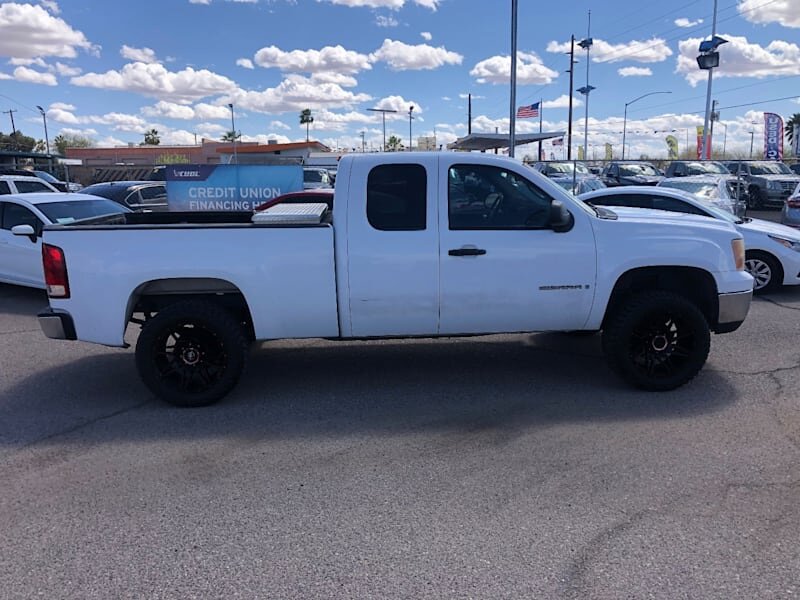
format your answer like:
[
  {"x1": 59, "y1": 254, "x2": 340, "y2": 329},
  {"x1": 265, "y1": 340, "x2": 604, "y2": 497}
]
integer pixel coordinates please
[{"x1": 603, "y1": 291, "x2": 711, "y2": 391}]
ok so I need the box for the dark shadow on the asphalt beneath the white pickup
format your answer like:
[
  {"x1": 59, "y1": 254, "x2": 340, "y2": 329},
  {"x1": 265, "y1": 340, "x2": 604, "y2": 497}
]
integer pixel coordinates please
[{"x1": 0, "y1": 334, "x2": 737, "y2": 448}]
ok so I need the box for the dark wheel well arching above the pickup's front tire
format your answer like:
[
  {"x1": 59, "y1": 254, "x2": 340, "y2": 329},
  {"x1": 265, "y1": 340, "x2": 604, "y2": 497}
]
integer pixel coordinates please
[{"x1": 603, "y1": 267, "x2": 719, "y2": 327}]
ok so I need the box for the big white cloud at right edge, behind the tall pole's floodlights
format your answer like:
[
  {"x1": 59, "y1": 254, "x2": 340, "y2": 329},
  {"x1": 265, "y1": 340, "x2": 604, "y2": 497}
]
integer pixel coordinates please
[{"x1": 675, "y1": 34, "x2": 800, "y2": 86}]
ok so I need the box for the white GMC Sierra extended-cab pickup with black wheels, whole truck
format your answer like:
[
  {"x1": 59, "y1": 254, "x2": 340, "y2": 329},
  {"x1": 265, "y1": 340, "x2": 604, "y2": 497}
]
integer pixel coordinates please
[{"x1": 34, "y1": 152, "x2": 753, "y2": 406}]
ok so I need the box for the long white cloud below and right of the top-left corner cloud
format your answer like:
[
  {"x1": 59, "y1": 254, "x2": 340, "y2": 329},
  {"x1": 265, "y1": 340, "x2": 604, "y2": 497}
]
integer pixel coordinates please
[{"x1": 70, "y1": 62, "x2": 236, "y2": 101}]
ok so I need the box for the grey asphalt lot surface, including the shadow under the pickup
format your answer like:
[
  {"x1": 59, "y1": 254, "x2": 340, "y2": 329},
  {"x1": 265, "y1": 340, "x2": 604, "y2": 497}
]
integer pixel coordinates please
[{"x1": 0, "y1": 285, "x2": 800, "y2": 598}]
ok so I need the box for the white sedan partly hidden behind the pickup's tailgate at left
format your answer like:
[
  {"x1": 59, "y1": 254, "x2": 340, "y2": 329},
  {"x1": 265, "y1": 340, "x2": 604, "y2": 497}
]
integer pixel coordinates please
[{"x1": 0, "y1": 191, "x2": 130, "y2": 289}]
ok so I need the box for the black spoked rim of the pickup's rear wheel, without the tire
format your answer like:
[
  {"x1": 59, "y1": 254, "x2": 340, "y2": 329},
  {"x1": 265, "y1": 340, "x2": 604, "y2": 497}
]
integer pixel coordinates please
[{"x1": 152, "y1": 321, "x2": 228, "y2": 394}]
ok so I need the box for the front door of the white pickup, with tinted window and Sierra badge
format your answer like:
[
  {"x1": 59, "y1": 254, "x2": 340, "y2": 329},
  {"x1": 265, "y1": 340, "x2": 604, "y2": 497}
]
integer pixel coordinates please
[{"x1": 439, "y1": 158, "x2": 597, "y2": 334}]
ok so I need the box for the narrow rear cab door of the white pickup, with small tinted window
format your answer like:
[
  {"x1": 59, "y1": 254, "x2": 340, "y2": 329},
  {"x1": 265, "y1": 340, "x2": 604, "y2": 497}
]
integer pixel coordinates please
[{"x1": 342, "y1": 153, "x2": 439, "y2": 337}]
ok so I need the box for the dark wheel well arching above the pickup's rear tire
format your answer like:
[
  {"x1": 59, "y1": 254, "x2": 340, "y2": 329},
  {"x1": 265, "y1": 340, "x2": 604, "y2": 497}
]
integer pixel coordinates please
[{"x1": 127, "y1": 277, "x2": 255, "y2": 340}]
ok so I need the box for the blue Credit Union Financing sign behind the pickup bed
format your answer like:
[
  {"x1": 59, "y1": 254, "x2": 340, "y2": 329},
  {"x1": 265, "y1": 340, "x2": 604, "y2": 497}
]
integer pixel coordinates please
[{"x1": 166, "y1": 165, "x2": 303, "y2": 211}]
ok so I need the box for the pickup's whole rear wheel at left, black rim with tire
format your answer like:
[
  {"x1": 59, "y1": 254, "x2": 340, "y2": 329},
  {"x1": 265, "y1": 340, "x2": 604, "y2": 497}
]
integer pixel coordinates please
[{"x1": 136, "y1": 300, "x2": 247, "y2": 407}]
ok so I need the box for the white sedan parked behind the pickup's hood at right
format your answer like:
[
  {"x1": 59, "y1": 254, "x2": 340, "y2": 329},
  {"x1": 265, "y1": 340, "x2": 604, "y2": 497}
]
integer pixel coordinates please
[{"x1": 578, "y1": 185, "x2": 800, "y2": 292}]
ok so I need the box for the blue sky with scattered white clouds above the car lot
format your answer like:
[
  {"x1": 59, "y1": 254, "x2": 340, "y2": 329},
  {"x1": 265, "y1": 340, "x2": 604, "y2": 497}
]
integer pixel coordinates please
[{"x1": 0, "y1": 0, "x2": 800, "y2": 157}]
